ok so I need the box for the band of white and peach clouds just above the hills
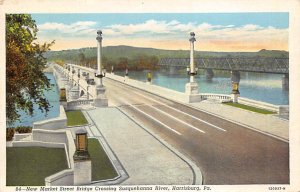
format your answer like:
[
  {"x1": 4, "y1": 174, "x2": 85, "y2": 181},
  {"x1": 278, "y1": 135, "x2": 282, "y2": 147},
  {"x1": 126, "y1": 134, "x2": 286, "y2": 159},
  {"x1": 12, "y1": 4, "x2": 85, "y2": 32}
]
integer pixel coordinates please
[{"x1": 38, "y1": 19, "x2": 288, "y2": 51}]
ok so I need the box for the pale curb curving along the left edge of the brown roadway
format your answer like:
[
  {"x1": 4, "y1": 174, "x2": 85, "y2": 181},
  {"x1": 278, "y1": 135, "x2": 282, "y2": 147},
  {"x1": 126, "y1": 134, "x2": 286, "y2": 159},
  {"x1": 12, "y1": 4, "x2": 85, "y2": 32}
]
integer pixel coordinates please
[{"x1": 116, "y1": 107, "x2": 203, "y2": 185}]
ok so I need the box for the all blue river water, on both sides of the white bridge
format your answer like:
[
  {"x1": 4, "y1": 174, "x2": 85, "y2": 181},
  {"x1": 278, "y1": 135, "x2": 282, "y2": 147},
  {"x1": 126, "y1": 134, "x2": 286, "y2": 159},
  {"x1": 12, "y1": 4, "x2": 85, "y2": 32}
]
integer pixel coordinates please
[{"x1": 8, "y1": 71, "x2": 289, "y2": 127}]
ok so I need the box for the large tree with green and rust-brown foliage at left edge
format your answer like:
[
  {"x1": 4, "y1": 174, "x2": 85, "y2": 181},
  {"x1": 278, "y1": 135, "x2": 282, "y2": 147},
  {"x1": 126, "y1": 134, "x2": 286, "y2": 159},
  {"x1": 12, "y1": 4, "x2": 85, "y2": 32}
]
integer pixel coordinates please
[{"x1": 6, "y1": 14, "x2": 54, "y2": 124}]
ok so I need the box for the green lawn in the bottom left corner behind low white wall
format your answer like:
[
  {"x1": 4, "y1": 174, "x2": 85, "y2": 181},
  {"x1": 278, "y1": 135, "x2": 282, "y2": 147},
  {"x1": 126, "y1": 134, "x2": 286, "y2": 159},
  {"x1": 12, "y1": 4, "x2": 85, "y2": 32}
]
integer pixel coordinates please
[{"x1": 6, "y1": 147, "x2": 68, "y2": 186}]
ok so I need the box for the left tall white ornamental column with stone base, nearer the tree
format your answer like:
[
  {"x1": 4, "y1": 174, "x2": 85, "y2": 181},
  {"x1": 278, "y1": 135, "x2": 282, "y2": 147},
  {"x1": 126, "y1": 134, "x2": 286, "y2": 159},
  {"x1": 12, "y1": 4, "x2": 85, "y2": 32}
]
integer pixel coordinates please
[{"x1": 94, "y1": 30, "x2": 108, "y2": 107}]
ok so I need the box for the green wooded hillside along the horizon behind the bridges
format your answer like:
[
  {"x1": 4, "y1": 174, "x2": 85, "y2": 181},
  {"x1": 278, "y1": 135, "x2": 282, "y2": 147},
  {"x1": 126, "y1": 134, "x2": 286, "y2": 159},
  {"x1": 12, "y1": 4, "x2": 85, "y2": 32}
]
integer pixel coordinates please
[{"x1": 45, "y1": 45, "x2": 289, "y2": 70}]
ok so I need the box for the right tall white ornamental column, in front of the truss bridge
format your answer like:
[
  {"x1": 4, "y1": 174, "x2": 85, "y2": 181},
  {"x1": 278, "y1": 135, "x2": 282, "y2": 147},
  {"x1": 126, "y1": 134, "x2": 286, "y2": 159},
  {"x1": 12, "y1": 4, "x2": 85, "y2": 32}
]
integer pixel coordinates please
[{"x1": 185, "y1": 32, "x2": 199, "y2": 95}]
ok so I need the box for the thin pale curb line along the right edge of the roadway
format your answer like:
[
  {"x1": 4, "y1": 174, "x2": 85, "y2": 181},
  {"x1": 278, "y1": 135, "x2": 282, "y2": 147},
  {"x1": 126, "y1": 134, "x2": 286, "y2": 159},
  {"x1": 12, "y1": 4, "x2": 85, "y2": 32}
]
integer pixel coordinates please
[{"x1": 105, "y1": 79, "x2": 289, "y2": 143}]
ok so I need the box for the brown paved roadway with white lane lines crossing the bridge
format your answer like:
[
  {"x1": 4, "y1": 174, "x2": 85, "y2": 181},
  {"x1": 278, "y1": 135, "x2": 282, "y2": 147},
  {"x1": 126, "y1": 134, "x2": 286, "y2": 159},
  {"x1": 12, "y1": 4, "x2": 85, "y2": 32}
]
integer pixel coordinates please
[{"x1": 104, "y1": 78, "x2": 289, "y2": 184}]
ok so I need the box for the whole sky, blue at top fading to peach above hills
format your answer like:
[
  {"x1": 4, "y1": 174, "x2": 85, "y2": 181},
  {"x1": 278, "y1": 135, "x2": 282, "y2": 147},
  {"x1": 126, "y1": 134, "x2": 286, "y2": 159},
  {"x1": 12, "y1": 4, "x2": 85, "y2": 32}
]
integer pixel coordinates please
[{"x1": 32, "y1": 12, "x2": 289, "y2": 52}]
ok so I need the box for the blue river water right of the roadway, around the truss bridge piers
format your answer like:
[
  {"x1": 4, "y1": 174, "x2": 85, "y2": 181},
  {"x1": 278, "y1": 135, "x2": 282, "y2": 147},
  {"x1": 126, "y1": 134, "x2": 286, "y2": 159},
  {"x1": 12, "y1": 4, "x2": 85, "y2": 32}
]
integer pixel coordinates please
[{"x1": 115, "y1": 70, "x2": 289, "y2": 105}]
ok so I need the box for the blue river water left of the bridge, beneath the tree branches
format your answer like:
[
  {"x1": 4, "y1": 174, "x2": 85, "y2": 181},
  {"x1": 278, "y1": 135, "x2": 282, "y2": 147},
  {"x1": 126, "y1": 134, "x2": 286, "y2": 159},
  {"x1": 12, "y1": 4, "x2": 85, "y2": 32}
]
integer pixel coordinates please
[{"x1": 11, "y1": 73, "x2": 59, "y2": 127}]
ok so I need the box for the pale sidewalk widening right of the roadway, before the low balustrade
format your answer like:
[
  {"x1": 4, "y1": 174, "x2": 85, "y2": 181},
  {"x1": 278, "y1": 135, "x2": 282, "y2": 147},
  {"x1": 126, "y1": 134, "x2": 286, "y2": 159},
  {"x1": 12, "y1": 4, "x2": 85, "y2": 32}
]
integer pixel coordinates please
[{"x1": 188, "y1": 101, "x2": 289, "y2": 141}]
